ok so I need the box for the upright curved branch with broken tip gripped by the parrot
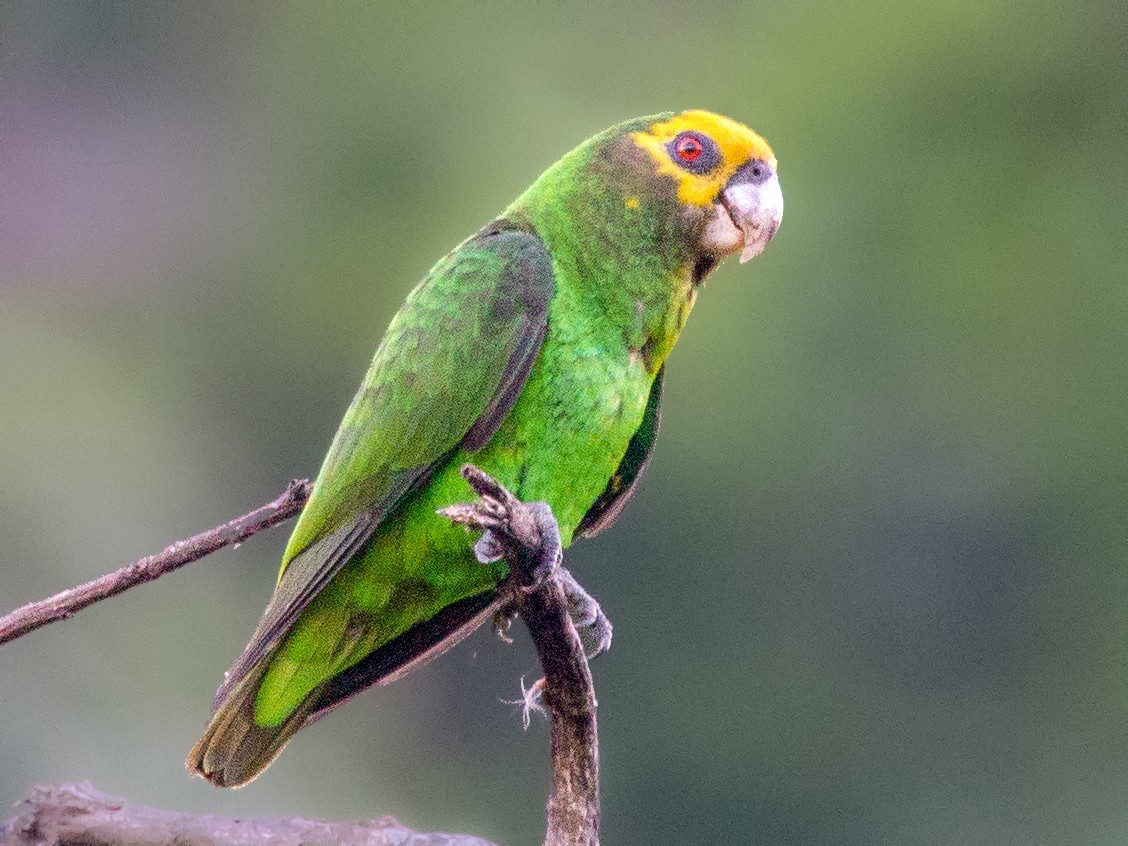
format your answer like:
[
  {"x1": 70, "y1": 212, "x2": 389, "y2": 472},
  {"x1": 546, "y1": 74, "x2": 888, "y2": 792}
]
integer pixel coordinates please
[{"x1": 440, "y1": 465, "x2": 599, "y2": 846}]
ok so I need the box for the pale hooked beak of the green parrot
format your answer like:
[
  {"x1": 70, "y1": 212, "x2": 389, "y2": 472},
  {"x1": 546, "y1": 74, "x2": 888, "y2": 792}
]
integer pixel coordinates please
[{"x1": 702, "y1": 159, "x2": 783, "y2": 264}]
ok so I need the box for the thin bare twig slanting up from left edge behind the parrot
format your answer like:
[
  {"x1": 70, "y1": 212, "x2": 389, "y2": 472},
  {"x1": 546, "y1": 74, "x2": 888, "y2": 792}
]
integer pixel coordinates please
[{"x1": 0, "y1": 479, "x2": 312, "y2": 644}]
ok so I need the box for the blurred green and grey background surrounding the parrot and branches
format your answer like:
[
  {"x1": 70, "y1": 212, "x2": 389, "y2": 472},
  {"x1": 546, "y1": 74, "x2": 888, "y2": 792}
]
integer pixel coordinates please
[{"x1": 0, "y1": 1, "x2": 1128, "y2": 846}]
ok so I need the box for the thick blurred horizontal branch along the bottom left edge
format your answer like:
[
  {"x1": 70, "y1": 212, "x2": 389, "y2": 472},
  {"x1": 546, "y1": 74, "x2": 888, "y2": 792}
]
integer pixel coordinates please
[{"x1": 0, "y1": 782, "x2": 494, "y2": 846}]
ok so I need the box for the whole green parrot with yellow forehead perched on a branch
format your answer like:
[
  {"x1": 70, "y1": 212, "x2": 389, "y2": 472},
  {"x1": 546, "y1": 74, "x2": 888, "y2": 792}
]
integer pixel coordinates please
[{"x1": 187, "y1": 111, "x2": 783, "y2": 786}]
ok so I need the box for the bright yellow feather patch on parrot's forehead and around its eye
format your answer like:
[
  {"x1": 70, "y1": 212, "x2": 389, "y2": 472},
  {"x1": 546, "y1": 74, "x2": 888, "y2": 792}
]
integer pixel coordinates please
[{"x1": 631, "y1": 109, "x2": 776, "y2": 205}]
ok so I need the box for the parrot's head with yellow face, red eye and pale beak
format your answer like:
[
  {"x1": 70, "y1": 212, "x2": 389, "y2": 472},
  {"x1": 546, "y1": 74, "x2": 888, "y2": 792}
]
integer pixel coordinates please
[{"x1": 508, "y1": 109, "x2": 783, "y2": 296}]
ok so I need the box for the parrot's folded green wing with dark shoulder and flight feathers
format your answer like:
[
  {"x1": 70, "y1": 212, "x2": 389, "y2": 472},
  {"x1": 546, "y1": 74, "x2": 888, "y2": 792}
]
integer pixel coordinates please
[{"x1": 208, "y1": 226, "x2": 554, "y2": 710}]
